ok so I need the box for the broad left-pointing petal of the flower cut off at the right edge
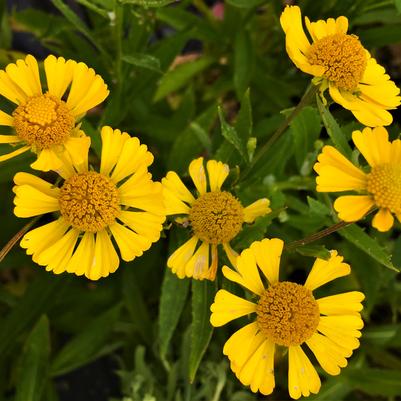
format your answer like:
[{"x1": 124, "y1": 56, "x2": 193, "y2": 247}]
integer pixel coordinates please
[{"x1": 313, "y1": 146, "x2": 367, "y2": 192}]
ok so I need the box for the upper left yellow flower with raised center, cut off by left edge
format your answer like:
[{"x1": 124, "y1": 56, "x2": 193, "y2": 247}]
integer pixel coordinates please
[{"x1": 0, "y1": 55, "x2": 109, "y2": 171}]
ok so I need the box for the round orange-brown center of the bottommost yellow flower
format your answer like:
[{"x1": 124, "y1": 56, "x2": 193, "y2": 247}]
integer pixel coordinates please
[{"x1": 256, "y1": 281, "x2": 320, "y2": 347}]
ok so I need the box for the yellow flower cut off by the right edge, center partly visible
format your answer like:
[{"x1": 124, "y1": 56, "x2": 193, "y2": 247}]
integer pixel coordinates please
[{"x1": 314, "y1": 127, "x2": 401, "y2": 231}]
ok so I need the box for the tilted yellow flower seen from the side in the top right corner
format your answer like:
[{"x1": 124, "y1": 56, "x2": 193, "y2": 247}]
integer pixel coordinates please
[{"x1": 280, "y1": 6, "x2": 401, "y2": 127}]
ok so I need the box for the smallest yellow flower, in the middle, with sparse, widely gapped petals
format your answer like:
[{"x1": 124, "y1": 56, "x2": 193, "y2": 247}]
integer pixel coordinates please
[{"x1": 162, "y1": 157, "x2": 271, "y2": 280}]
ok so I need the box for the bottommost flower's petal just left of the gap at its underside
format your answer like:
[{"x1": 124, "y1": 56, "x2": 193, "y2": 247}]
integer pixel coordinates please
[{"x1": 236, "y1": 340, "x2": 275, "y2": 395}]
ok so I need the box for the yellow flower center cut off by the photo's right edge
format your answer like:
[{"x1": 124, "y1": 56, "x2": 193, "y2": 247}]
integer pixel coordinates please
[{"x1": 368, "y1": 164, "x2": 401, "y2": 213}]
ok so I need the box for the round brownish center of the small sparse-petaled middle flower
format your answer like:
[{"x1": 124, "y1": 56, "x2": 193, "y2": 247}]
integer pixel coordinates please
[{"x1": 189, "y1": 191, "x2": 244, "y2": 244}]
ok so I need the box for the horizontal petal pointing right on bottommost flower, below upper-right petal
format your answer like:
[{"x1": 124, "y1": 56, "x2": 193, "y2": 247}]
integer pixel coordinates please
[{"x1": 317, "y1": 291, "x2": 365, "y2": 315}]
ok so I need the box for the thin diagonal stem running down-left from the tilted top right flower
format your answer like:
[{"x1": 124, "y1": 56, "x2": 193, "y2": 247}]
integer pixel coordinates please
[{"x1": 241, "y1": 84, "x2": 319, "y2": 181}]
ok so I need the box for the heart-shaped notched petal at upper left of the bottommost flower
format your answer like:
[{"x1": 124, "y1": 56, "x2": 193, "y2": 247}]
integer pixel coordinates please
[{"x1": 223, "y1": 249, "x2": 264, "y2": 295}]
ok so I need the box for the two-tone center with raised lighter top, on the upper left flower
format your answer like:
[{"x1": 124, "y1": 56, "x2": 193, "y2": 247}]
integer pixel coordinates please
[{"x1": 13, "y1": 93, "x2": 75, "y2": 150}]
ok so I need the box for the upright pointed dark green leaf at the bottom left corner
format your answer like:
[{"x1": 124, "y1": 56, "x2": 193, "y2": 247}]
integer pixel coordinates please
[{"x1": 15, "y1": 316, "x2": 50, "y2": 401}]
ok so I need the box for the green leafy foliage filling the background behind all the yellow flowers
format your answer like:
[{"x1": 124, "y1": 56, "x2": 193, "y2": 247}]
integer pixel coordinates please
[{"x1": 0, "y1": 0, "x2": 401, "y2": 401}]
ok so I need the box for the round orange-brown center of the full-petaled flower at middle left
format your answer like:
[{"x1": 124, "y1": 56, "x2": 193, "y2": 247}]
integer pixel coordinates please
[{"x1": 59, "y1": 171, "x2": 120, "y2": 232}]
